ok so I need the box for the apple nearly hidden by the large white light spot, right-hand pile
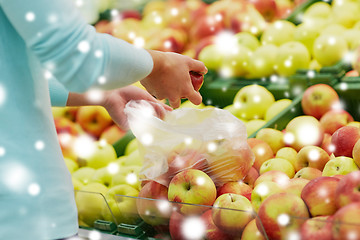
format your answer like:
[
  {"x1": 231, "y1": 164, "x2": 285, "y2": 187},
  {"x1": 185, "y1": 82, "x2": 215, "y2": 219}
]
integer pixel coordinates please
[{"x1": 284, "y1": 115, "x2": 324, "y2": 151}]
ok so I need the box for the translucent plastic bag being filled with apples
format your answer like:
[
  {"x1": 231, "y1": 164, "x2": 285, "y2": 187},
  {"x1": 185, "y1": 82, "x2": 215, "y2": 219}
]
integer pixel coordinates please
[{"x1": 125, "y1": 100, "x2": 255, "y2": 186}]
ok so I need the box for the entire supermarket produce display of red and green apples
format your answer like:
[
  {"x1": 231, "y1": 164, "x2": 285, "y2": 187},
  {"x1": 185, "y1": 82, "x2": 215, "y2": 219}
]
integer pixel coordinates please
[{"x1": 47, "y1": 0, "x2": 360, "y2": 240}]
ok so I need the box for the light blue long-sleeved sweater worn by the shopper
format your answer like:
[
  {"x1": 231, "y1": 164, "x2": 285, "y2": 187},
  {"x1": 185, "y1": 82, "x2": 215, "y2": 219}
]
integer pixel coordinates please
[{"x1": 0, "y1": 0, "x2": 153, "y2": 240}]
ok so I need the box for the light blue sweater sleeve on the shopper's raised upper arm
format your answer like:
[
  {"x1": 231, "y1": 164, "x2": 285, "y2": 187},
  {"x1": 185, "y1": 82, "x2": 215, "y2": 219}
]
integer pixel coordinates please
[{"x1": 0, "y1": 0, "x2": 153, "y2": 92}]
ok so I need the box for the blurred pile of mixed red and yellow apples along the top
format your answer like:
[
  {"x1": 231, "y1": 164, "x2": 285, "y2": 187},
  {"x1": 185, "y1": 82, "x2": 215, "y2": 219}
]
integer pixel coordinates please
[{"x1": 95, "y1": 0, "x2": 304, "y2": 58}]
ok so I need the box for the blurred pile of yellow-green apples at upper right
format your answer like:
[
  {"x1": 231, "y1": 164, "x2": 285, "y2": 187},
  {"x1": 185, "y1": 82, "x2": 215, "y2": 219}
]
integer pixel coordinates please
[{"x1": 198, "y1": 0, "x2": 360, "y2": 78}]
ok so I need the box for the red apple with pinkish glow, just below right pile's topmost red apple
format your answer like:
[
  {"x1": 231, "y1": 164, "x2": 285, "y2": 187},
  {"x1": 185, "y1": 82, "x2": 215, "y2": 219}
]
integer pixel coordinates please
[{"x1": 320, "y1": 109, "x2": 354, "y2": 134}]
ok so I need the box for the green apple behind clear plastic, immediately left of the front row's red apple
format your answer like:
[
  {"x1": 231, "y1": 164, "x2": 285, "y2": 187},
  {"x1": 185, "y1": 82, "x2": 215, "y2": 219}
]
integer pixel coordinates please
[{"x1": 102, "y1": 184, "x2": 140, "y2": 224}]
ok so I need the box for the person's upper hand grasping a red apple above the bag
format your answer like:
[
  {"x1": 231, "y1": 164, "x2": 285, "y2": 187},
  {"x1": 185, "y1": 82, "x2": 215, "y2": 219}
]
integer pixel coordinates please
[{"x1": 141, "y1": 50, "x2": 207, "y2": 108}]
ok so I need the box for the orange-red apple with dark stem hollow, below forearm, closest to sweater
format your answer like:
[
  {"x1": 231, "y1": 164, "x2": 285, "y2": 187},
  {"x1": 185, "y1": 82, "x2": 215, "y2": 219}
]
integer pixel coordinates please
[{"x1": 76, "y1": 106, "x2": 113, "y2": 138}]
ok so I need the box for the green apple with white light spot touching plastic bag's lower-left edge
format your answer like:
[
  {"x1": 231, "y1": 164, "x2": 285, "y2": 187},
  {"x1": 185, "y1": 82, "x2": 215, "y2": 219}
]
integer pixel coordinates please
[{"x1": 111, "y1": 165, "x2": 142, "y2": 190}]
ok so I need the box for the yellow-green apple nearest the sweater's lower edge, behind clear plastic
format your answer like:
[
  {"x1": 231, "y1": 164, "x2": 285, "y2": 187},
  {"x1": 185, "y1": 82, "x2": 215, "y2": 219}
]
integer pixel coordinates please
[{"x1": 75, "y1": 183, "x2": 108, "y2": 227}]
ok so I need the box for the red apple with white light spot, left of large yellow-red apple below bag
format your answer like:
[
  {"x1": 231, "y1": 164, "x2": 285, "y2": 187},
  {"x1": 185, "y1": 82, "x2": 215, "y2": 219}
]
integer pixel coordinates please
[{"x1": 136, "y1": 181, "x2": 171, "y2": 226}]
